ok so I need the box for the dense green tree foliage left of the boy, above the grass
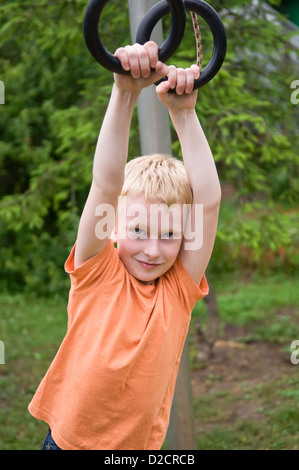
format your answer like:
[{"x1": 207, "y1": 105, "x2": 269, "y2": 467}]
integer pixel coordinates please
[{"x1": 0, "y1": 0, "x2": 129, "y2": 294}]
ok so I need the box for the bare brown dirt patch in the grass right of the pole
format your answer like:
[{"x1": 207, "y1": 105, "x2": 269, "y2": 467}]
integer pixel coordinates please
[{"x1": 191, "y1": 327, "x2": 298, "y2": 433}]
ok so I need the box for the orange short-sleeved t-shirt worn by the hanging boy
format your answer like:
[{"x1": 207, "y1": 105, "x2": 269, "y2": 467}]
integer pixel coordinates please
[{"x1": 29, "y1": 241, "x2": 208, "y2": 450}]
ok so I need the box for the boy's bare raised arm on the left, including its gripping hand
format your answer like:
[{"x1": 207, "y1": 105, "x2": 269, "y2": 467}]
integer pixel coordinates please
[{"x1": 75, "y1": 41, "x2": 168, "y2": 268}]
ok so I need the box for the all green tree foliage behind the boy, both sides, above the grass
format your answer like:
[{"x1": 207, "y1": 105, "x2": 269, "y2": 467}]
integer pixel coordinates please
[{"x1": 0, "y1": 0, "x2": 299, "y2": 294}]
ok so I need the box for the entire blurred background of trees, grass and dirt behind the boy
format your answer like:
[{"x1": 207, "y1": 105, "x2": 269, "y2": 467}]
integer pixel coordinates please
[{"x1": 0, "y1": 0, "x2": 299, "y2": 450}]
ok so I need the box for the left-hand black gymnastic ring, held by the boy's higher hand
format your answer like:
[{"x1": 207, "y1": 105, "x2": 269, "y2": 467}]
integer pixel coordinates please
[{"x1": 83, "y1": 0, "x2": 186, "y2": 75}]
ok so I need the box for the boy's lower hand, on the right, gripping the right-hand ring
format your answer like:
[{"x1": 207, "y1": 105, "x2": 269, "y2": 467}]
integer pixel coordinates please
[{"x1": 156, "y1": 65, "x2": 200, "y2": 113}]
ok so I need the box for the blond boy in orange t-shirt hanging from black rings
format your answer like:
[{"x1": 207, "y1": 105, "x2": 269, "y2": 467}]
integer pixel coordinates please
[{"x1": 29, "y1": 41, "x2": 221, "y2": 450}]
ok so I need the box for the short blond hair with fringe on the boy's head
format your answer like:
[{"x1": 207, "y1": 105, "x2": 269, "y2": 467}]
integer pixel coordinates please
[{"x1": 121, "y1": 154, "x2": 193, "y2": 206}]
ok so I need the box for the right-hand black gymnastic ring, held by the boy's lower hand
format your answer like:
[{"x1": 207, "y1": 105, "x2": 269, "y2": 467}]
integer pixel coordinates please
[{"x1": 136, "y1": 0, "x2": 226, "y2": 89}]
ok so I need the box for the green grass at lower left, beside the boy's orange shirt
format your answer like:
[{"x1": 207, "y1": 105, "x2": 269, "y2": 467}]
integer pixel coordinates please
[{"x1": 0, "y1": 295, "x2": 67, "y2": 450}]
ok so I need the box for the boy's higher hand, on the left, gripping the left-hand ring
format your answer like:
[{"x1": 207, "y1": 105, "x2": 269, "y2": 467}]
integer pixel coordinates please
[{"x1": 114, "y1": 41, "x2": 169, "y2": 92}]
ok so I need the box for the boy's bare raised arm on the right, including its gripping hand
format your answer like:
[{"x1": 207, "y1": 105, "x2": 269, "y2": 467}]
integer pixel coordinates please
[{"x1": 157, "y1": 66, "x2": 221, "y2": 284}]
